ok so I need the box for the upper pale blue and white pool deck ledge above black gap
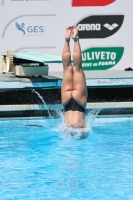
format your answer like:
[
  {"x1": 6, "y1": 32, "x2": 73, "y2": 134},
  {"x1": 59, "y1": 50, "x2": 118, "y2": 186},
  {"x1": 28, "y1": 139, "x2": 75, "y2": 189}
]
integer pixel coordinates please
[{"x1": 0, "y1": 70, "x2": 133, "y2": 90}]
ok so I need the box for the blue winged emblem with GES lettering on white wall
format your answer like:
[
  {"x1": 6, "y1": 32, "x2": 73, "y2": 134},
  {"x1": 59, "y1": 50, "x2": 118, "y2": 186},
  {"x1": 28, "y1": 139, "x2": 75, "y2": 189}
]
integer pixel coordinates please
[{"x1": 15, "y1": 22, "x2": 45, "y2": 35}]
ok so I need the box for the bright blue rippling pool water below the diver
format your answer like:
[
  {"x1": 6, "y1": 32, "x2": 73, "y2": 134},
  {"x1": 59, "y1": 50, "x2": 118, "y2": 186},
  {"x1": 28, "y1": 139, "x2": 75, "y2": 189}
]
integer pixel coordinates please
[{"x1": 0, "y1": 118, "x2": 133, "y2": 200}]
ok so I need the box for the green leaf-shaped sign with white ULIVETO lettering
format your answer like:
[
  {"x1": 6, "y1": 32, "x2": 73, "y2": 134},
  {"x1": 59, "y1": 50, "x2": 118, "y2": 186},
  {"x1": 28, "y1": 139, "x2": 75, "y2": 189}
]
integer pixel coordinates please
[{"x1": 82, "y1": 47, "x2": 124, "y2": 70}]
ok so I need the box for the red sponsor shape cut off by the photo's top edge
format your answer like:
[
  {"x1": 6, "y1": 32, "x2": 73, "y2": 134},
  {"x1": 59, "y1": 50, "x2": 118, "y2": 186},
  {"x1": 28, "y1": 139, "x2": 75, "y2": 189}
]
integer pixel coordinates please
[{"x1": 72, "y1": 0, "x2": 116, "y2": 6}]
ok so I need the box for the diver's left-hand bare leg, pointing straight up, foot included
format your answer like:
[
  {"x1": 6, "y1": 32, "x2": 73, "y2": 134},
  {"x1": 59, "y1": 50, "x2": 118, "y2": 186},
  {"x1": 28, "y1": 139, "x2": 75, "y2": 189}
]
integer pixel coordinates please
[{"x1": 61, "y1": 27, "x2": 73, "y2": 105}]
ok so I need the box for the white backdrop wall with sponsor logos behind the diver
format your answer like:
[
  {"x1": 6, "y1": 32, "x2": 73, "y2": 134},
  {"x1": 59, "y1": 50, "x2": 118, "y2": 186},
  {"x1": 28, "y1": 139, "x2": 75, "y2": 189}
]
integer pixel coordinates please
[{"x1": 0, "y1": 0, "x2": 133, "y2": 71}]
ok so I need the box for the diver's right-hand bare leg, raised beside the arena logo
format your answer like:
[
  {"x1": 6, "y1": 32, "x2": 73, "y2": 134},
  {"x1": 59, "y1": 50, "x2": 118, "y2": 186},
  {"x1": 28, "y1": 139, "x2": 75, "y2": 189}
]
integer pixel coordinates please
[{"x1": 72, "y1": 26, "x2": 87, "y2": 108}]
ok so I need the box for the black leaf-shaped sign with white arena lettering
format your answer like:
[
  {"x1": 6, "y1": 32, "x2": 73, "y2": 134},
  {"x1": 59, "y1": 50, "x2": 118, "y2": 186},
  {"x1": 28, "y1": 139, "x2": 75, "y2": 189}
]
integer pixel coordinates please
[{"x1": 77, "y1": 15, "x2": 124, "y2": 39}]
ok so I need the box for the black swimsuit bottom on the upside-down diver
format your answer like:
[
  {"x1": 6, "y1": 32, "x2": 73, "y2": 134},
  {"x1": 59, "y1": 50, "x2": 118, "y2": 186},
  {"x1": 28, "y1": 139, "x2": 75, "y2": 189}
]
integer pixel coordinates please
[{"x1": 64, "y1": 98, "x2": 85, "y2": 113}]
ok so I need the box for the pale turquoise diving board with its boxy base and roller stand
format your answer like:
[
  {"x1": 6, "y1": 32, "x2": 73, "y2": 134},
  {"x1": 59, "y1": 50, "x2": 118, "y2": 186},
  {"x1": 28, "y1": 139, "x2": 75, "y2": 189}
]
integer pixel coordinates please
[{"x1": 2, "y1": 50, "x2": 62, "y2": 77}]
